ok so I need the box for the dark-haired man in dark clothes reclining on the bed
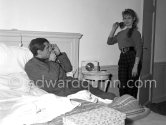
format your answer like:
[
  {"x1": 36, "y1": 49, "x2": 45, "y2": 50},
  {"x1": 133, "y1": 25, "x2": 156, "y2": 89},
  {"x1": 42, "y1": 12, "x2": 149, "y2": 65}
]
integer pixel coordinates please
[{"x1": 25, "y1": 38, "x2": 115, "y2": 100}]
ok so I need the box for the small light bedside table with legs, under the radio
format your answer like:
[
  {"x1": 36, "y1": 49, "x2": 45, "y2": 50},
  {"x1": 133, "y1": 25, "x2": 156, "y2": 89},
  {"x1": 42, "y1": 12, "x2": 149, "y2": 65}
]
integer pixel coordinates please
[{"x1": 82, "y1": 71, "x2": 112, "y2": 92}]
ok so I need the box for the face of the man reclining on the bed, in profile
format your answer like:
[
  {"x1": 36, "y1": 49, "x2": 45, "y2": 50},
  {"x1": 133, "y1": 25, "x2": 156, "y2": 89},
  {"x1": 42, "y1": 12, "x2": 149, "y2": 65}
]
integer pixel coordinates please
[{"x1": 38, "y1": 42, "x2": 51, "y2": 59}]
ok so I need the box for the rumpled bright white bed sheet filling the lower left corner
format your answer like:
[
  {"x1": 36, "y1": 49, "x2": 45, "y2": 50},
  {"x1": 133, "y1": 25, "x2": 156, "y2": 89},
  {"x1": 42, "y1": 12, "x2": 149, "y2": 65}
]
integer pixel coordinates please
[{"x1": 0, "y1": 73, "x2": 80, "y2": 125}]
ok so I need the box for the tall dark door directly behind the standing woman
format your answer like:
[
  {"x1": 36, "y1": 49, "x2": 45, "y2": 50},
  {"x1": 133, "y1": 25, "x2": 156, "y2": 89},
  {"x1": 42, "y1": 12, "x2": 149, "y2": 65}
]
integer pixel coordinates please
[{"x1": 139, "y1": 0, "x2": 156, "y2": 105}]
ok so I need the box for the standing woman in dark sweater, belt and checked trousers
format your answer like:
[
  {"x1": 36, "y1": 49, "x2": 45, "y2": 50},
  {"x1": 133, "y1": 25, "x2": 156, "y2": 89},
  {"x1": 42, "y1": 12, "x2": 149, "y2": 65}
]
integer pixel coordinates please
[{"x1": 107, "y1": 9, "x2": 143, "y2": 98}]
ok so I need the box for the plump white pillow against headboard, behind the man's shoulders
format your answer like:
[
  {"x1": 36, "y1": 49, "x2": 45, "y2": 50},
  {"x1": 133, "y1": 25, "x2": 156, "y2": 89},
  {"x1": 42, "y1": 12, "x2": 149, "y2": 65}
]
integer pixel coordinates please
[{"x1": 0, "y1": 43, "x2": 33, "y2": 74}]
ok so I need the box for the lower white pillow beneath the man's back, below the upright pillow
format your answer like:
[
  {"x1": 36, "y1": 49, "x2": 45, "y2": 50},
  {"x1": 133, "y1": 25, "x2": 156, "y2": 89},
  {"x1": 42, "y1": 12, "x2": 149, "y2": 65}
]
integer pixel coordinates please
[{"x1": 0, "y1": 73, "x2": 47, "y2": 100}]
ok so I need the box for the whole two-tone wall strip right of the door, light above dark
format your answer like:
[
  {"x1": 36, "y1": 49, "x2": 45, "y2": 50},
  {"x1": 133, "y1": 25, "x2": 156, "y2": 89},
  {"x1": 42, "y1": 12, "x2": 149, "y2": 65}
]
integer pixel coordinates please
[{"x1": 152, "y1": 0, "x2": 166, "y2": 102}]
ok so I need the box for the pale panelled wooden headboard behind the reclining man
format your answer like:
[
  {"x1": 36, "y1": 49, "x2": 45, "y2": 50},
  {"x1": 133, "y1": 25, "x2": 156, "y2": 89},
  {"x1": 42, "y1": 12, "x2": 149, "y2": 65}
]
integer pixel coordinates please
[{"x1": 0, "y1": 30, "x2": 82, "y2": 77}]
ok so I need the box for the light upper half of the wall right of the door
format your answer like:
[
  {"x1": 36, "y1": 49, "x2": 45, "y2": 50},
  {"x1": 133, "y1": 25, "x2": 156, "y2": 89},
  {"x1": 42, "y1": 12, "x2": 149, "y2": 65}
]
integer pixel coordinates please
[{"x1": 154, "y1": 0, "x2": 166, "y2": 62}]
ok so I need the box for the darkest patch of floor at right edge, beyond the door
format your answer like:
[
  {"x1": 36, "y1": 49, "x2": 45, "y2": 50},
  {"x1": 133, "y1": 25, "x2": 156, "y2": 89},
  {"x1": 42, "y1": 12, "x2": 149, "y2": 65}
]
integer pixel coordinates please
[{"x1": 147, "y1": 101, "x2": 166, "y2": 116}]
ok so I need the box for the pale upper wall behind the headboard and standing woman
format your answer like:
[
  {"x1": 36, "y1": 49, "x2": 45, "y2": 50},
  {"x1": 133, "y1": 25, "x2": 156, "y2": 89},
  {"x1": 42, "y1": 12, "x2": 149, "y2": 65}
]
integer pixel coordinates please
[{"x1": 0, "y1": 0, "x2": 143, "y2": 65}]
